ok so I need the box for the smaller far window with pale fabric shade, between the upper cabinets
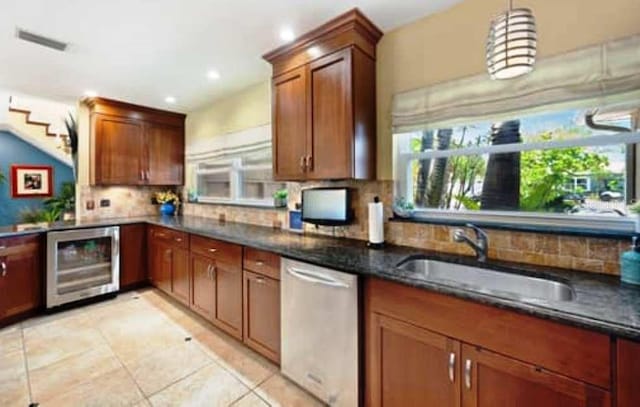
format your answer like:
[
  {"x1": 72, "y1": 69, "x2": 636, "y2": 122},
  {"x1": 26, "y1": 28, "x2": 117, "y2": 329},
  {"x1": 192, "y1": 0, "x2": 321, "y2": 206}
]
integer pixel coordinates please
[{"x1": 187, "y1": 126, "x2": 286, "y2": 207}]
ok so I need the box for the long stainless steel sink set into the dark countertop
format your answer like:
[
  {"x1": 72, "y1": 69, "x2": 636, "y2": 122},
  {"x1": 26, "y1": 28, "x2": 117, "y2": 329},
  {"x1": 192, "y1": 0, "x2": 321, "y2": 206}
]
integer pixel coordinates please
[{"x1": 398, "y1": 258, "x2": 575, "y2": 301}]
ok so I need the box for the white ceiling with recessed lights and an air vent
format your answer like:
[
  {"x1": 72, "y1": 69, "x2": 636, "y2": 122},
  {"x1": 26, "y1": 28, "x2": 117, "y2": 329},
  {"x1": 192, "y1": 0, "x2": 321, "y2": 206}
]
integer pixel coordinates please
[{"x1": 0, "y1": 0, "x2": 460, "y2": 112}]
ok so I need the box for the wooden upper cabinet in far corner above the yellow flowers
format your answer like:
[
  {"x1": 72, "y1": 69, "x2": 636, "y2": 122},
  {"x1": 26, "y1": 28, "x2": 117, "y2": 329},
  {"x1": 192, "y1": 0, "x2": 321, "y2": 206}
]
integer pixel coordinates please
[{"x1": 86, "y1": 98, "x2": 185, "y2": 185}]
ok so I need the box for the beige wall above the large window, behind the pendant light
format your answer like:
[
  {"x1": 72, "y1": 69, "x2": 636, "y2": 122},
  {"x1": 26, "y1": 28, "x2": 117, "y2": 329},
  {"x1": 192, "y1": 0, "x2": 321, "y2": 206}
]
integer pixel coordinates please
[{"x1": 377, "y1": 0, "x2": 640, "y2": 179}]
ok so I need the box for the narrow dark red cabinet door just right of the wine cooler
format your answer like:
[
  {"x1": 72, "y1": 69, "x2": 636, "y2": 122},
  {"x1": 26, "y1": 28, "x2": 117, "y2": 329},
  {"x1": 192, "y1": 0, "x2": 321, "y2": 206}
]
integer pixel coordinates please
[{"x1": 120, "y1": 223, "x2": 147, "y2": 289}]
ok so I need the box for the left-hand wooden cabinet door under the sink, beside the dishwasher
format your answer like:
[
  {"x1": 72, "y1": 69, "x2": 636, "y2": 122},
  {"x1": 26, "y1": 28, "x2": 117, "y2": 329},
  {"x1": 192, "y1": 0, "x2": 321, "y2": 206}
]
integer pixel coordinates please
[{"x1": 366, "y1": 313, "x2": 460, "y2": 407}]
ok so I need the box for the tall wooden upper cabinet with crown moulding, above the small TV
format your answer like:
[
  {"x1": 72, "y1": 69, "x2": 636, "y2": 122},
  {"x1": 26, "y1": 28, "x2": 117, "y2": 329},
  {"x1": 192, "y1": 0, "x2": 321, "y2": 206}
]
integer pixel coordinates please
[{"x1": 264, "y1": 9, "x2": 382, "y2": 180}]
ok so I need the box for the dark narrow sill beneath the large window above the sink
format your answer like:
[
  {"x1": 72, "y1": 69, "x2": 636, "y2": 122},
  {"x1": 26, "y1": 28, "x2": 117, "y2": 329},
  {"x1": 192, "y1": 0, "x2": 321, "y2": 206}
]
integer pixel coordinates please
[{"x1": 389, "y1": 216, "x2": 636, "y2": 240}]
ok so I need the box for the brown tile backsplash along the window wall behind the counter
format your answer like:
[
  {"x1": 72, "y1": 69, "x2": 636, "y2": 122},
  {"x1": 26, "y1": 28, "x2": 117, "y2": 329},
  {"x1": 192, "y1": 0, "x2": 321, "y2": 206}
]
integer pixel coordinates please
[{"x1": 183, "y1": 181, "x2": 629, "y2": 275}]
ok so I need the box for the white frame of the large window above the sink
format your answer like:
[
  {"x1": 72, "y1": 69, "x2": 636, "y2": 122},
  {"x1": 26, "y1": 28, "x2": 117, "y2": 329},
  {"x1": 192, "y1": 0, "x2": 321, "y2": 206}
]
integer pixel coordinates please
[{"x1": 392, "y1": 113, "x2": 640, "y2": 232}]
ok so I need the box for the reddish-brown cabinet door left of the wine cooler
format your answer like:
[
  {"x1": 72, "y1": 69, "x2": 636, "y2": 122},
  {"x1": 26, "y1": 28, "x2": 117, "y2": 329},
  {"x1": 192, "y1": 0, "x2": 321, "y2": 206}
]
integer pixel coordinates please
[{"x1": 0, "y1": 238, "x2": 43, "y2": 319}]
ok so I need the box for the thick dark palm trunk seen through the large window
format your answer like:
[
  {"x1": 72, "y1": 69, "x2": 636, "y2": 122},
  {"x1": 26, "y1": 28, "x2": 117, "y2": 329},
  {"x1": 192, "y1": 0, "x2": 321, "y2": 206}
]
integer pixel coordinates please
[{"x1": 480, "y1": 120, "x2": 521, "y2": 210}]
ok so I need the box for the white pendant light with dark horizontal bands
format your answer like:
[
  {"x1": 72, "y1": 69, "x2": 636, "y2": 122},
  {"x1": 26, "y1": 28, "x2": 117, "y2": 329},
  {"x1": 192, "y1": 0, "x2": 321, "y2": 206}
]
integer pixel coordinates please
[{"x1": 486, "y1": 0, "x2": 537, "y2": 79}]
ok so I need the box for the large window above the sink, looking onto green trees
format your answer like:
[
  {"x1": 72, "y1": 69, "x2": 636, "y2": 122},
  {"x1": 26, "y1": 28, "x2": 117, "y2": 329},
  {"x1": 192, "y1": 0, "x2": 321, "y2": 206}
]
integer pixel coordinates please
[{"x1": 394, "y1": 108, "x2": 640, "y2": 228}]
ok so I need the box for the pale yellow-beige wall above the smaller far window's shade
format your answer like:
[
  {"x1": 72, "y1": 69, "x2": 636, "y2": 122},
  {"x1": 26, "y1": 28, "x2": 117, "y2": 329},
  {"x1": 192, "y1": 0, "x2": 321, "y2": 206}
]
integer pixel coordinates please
[{"x1": 186, "y1": 81, "x2": 271, "y2": 151}]
